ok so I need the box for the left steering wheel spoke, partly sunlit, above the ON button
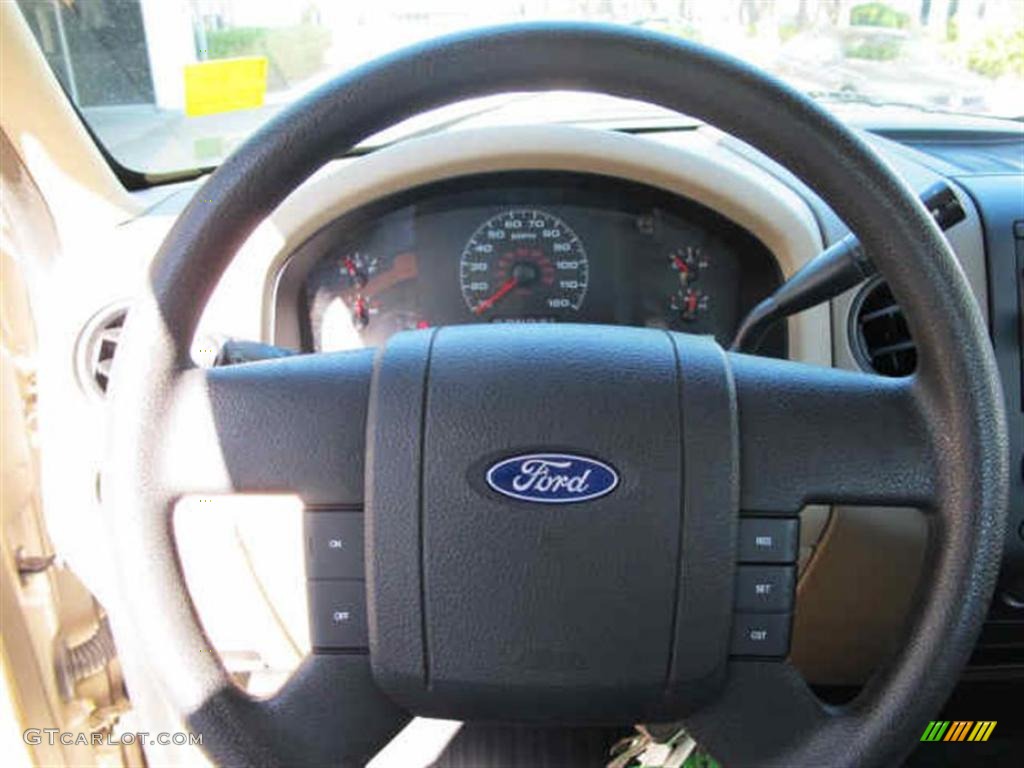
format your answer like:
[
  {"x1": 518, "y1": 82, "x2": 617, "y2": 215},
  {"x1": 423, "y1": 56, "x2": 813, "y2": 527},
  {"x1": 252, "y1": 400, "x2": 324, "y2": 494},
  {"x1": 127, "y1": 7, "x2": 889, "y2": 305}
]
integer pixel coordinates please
[{"x1": 161, "y1": 350, "x2": 373, "y2": 507}]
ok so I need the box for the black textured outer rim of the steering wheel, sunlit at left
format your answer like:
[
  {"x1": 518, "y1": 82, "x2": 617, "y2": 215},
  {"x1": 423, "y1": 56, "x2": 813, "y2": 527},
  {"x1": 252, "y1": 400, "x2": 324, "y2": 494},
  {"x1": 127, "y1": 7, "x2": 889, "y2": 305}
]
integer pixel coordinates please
[{"x1": 104, "y1": 24, "x2": 1009, "y2": 766}]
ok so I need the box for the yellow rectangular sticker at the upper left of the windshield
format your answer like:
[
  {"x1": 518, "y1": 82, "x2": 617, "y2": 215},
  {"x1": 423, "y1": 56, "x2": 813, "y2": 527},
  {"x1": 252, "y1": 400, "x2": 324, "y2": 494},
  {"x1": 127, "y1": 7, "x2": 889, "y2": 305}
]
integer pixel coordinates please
[{"x1": 185, "y1": 56, "x2": 267, "y2": 118}]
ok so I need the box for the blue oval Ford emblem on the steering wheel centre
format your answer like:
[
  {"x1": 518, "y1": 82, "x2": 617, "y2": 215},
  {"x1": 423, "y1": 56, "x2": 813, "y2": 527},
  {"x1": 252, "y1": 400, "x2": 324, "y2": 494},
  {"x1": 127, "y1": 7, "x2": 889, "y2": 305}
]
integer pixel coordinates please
[{"x1": 487, "y1": 454, "x2": 618, "y2": 504}]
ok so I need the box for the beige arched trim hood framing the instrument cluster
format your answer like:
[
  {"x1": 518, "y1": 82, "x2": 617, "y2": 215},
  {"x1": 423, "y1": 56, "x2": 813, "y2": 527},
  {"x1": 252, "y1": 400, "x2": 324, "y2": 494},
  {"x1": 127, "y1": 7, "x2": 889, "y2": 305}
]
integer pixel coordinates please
[{"x1": 247, "y1": 126, "x2": 831, "y2": 366}]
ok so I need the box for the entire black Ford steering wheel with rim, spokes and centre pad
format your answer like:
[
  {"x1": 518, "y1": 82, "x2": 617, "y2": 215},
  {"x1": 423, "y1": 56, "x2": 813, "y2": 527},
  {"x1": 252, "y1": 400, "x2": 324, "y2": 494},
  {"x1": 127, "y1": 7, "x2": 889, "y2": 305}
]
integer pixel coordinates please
[{"x1": 104, "y1": 24, "x2": 1009, "y2": 766}]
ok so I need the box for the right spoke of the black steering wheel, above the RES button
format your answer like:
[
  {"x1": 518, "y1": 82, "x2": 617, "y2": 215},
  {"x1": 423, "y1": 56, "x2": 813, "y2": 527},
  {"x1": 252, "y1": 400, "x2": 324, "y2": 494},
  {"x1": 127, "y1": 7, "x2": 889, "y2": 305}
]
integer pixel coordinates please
[{"x1": 730, "y1": 354, "x2": 936, "y2": 514}]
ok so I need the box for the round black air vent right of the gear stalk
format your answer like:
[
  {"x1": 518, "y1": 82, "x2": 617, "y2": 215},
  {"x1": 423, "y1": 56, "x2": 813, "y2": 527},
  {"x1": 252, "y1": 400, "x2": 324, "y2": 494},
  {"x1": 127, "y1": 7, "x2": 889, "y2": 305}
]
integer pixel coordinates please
[{"x1": 850, "y1": 280, "x2": 918, "y2": 376}]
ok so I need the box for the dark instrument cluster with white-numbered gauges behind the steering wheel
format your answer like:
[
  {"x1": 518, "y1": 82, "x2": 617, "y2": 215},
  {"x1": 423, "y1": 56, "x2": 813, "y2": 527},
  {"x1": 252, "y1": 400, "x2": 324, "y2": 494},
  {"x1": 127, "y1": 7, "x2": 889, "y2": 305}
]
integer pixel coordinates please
[{"x1": 275, "y1": 171, "x2": 786, "y2": 356}]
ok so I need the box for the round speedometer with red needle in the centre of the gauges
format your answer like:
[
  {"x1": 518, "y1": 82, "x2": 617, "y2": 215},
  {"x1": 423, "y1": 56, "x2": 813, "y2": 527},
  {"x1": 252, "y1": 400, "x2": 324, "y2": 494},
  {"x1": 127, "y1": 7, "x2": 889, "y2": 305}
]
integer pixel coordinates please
[{"x1": 459, "y1": 209, "x2": 590, "y2": 322}]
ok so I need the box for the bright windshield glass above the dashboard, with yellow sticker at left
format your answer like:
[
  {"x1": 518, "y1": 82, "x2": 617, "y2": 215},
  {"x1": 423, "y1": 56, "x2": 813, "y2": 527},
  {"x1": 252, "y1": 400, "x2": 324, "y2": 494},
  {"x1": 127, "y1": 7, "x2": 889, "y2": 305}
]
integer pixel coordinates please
[{"x1": 17, "y1": 0, "x2": 1024, "y2": 173}]
